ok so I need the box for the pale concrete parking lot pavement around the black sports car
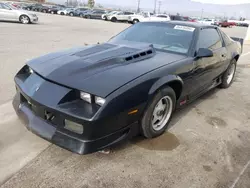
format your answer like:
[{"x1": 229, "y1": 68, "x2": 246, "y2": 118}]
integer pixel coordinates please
[{"x1": 0, "y1": 13, "x2": 250, "y2": 188}]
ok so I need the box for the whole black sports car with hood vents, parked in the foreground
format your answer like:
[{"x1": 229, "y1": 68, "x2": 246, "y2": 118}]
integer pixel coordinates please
[{"x1": 13, "y1": 21, "x2": 243, "y2": 154}]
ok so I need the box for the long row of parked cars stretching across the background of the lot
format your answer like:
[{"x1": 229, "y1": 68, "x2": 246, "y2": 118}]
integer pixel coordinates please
[{"x1": 0, "y1": 2, "x2": 249, "y2": 27}]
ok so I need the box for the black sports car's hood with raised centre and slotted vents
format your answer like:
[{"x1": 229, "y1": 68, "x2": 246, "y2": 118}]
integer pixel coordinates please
[{"x1": 27, "y1": 42, "x2": 186, "y2": 97}]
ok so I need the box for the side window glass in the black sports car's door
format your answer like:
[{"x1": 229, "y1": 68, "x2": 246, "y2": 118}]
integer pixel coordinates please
[{"x1": 197, "y1": 28, "x2": 222, "y2": 50}]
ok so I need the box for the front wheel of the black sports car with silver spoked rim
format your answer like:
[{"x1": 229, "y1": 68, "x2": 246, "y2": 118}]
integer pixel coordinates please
[{"x1": 141, "y1": 87, "x2": 176, "y2": 138}]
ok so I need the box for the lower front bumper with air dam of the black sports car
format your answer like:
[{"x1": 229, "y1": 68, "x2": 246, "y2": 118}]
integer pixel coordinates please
[{"x1": 12, "y1": 91, "x2": 138, "y2": 154}]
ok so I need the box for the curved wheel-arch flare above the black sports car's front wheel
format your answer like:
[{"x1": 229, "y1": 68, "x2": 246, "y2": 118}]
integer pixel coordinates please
[{"x1": 148, "y1": 75, "x2": 183, "y2": 96}]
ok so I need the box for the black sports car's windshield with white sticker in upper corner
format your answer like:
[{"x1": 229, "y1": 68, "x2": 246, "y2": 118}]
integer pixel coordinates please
[{"x1": 110, "y1": 22, "x2": 195, "y2": 54}]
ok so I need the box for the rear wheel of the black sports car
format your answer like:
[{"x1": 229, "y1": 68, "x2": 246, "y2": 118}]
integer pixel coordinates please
[{"x1": 220, "y1": 59, "x2": 237, "y2": 89}]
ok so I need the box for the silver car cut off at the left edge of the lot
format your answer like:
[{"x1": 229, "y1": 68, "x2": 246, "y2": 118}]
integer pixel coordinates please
[{"x1": 0, "y1": 2, "x2": 38, "y2": 24}]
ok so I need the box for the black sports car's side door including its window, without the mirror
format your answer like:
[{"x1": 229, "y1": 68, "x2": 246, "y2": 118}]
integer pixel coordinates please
[{"x1": 191, "y1": 28, "x2": 226, "y2": 98}]
